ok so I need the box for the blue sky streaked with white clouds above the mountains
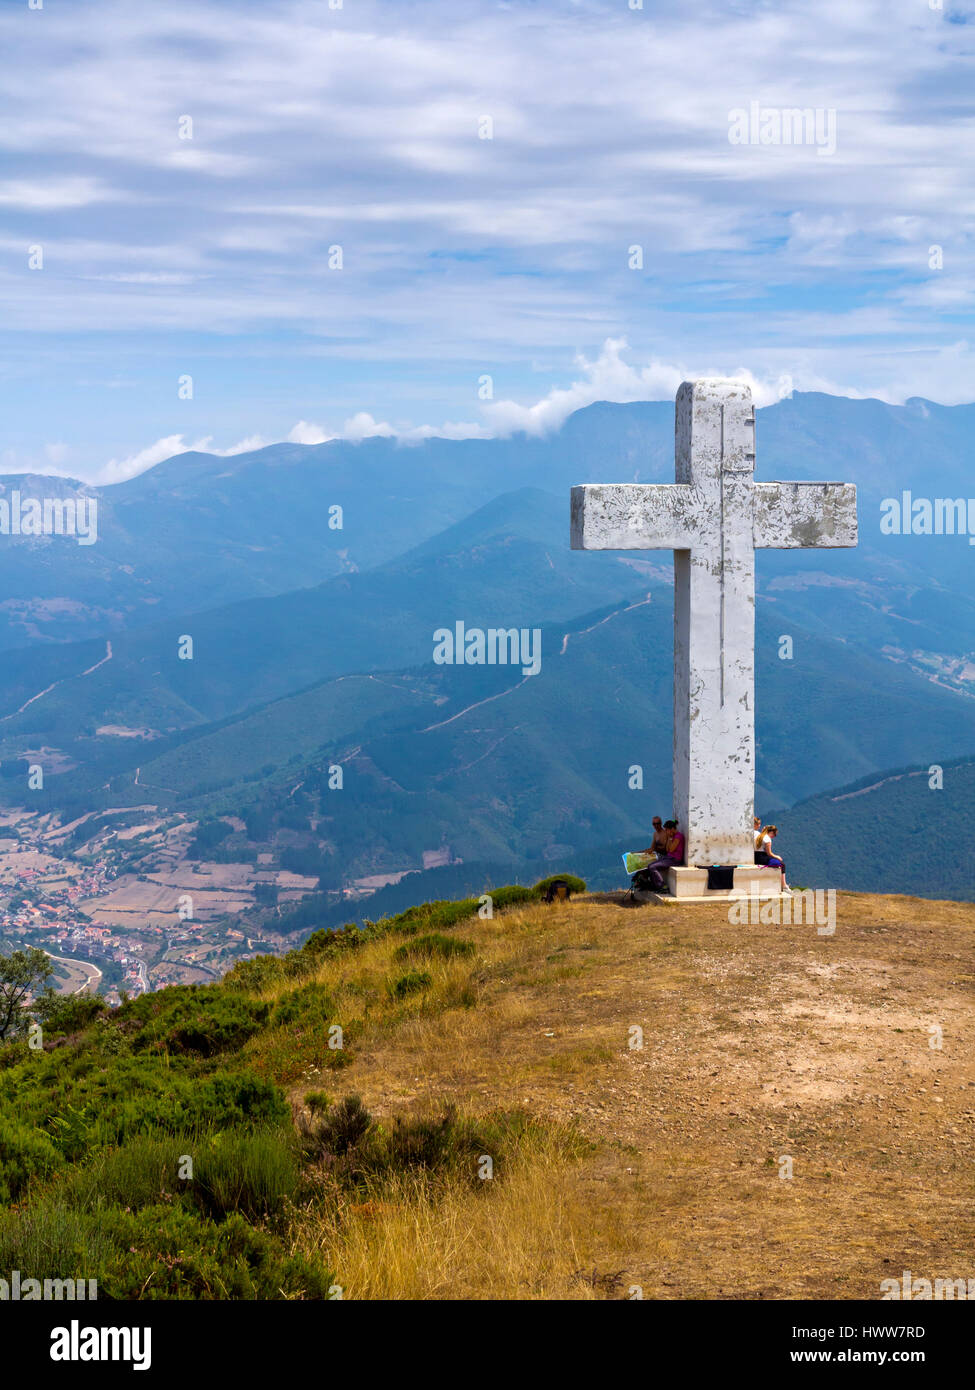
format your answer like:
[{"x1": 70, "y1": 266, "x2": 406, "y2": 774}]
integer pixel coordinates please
[{"x1": 0, "y1": 0, "x2": 975, "y2": 481}]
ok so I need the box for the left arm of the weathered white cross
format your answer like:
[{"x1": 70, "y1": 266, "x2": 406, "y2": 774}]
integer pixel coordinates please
[{"x1": 572, "y1": 482, "x2": 695, "y2": 550}]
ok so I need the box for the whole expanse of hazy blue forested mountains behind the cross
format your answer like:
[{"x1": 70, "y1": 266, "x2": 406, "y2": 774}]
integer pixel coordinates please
[{"x1": 0, "y1": 395, "x2": 975, "y2": 885}]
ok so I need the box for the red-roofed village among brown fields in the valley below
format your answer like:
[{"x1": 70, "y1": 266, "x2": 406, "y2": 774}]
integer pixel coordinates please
[{"x1": 0, "y1": 806, "x2": 322, "y2": 1005}]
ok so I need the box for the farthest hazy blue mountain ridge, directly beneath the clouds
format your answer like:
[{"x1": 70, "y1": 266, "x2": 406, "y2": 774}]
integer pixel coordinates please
[{"x1": 7, "y1": 392, "x2": 975, "y2": 648}]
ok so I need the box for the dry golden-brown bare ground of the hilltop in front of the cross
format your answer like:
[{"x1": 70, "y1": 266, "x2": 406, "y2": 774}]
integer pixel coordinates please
[{"x1": 341, "y1": 894, "x2": 975, "y2": 1300}]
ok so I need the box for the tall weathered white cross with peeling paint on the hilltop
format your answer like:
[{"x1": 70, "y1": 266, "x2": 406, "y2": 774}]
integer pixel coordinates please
[{"x1": 572, "y1": 379, "x2": 857, "y2": 866}]
